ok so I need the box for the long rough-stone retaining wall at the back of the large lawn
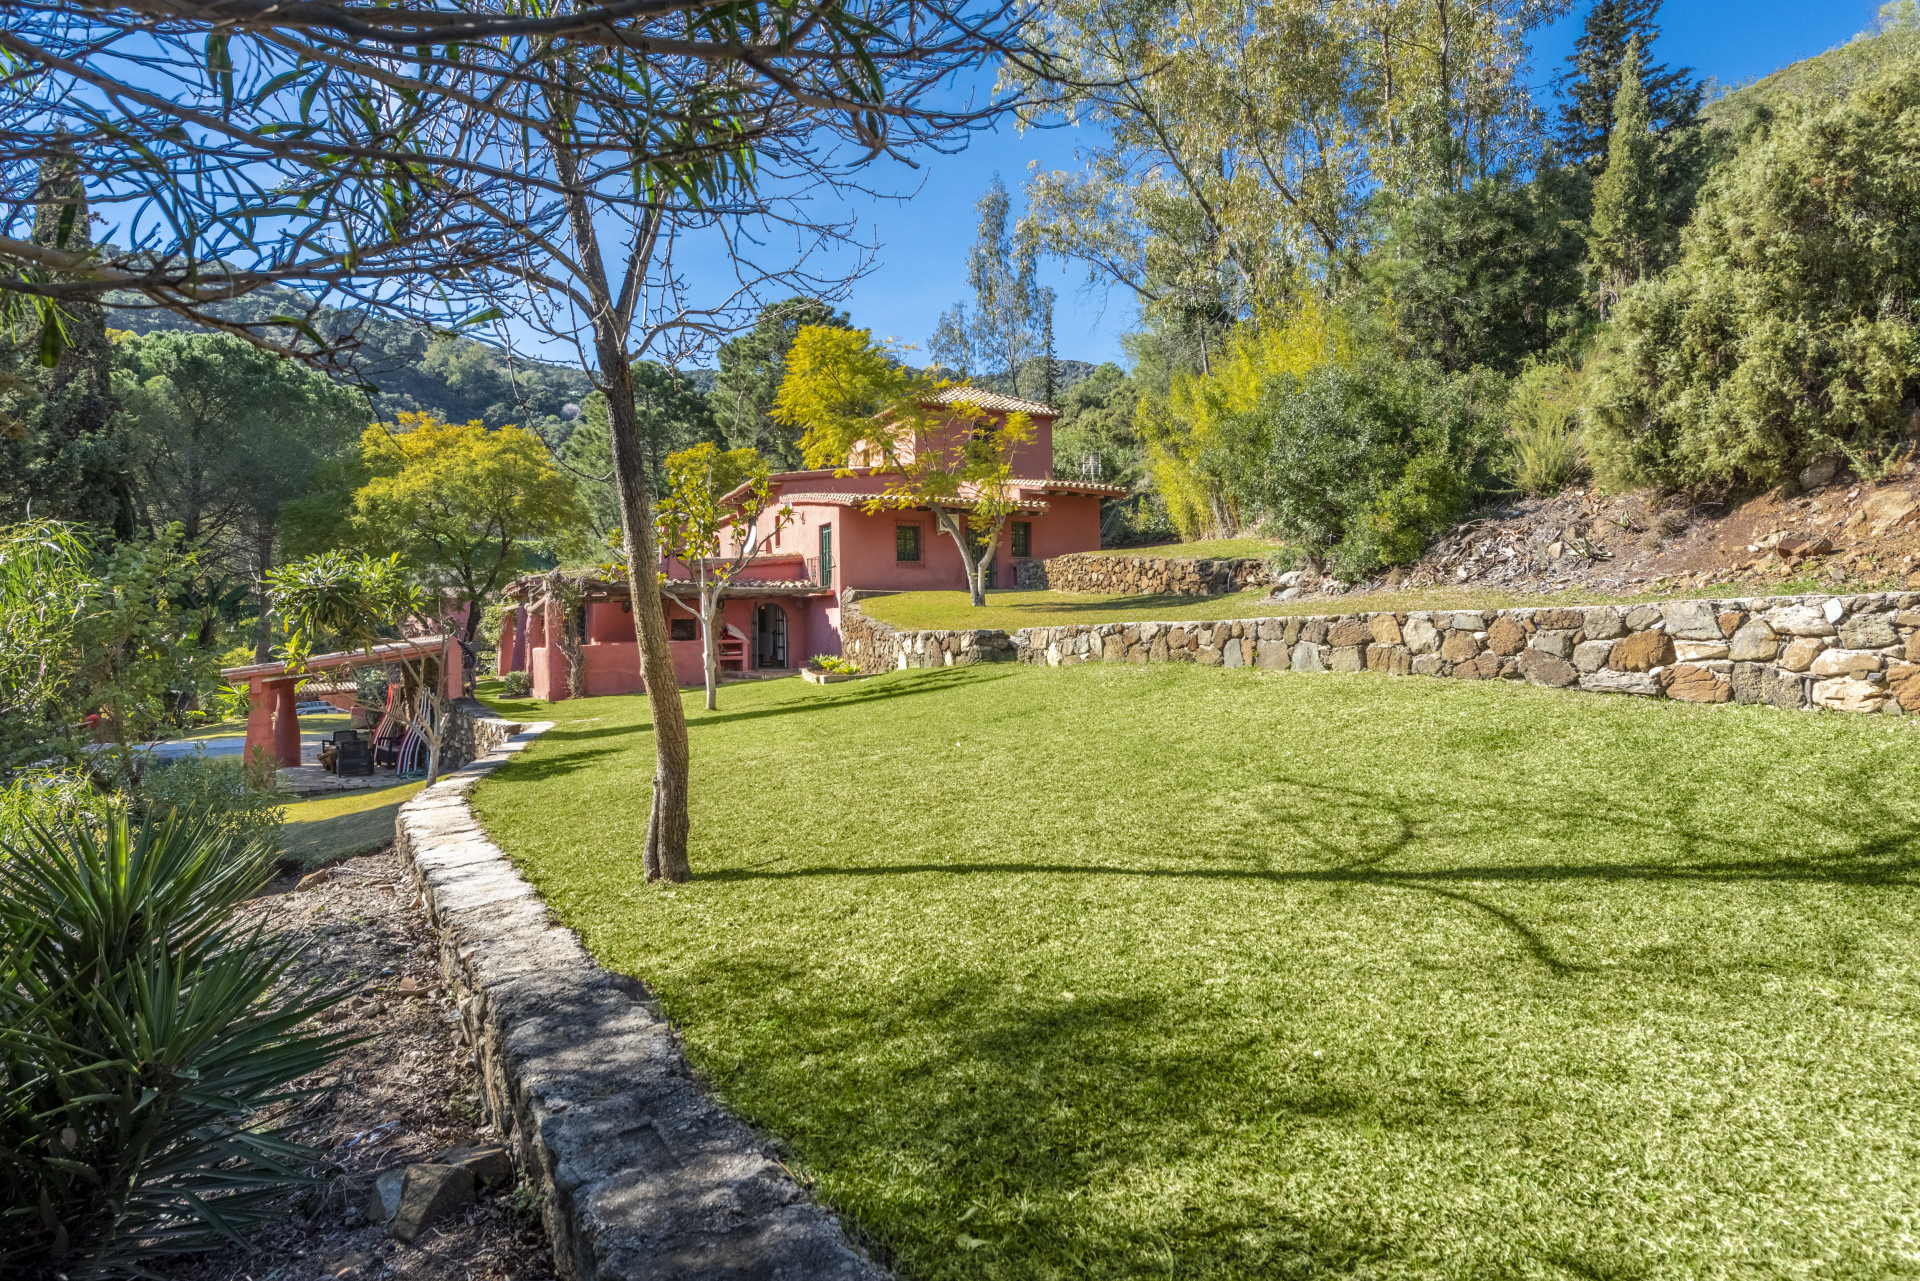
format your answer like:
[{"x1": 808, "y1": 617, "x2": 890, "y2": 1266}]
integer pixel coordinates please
[{"x1": 843, "y1": 592, "x2": 1920, "y2": 714}]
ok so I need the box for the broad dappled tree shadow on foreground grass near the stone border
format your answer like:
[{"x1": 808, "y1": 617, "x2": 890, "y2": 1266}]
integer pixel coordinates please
[{"x1": 687, "y1": 956, "x2": 1390, "y2": 1277}]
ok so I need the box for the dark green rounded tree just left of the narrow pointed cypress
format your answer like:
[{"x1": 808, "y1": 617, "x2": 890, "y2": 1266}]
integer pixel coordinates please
[{"x1": 1369, "y1": 169, "x2": 1588, "y2": 375}]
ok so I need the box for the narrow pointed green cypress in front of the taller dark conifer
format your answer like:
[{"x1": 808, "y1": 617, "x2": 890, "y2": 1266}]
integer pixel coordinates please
[{"x1": 1586, "y1": 36, "x2": 1667, "y2": 313}]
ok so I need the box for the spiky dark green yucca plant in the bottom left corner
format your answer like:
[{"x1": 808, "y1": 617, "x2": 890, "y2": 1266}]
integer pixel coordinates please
[{"x1": 0, "y1": 816, "x2": 348, "y2": 1279}]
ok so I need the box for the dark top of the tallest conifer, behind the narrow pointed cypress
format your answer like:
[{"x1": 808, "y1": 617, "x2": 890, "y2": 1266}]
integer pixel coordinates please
[{"x1": 1555, "y1": 0, "x2": 1703, "y2": 177}]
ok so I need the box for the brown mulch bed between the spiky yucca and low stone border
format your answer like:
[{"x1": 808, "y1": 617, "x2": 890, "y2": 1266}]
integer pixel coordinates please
[{"x1": 167, "y1": 849, "x2": 555, "y2": 1281}]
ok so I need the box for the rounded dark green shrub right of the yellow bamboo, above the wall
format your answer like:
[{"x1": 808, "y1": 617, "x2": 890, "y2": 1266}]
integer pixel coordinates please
[{"x1": 1217, "y1": 355, "x2": 1492, "y2": 580}]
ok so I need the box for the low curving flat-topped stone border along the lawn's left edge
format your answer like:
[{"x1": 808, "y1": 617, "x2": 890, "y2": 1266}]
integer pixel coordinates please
[{"x1": 396, "y1": 722, "x2": 889, "y2": 1281}]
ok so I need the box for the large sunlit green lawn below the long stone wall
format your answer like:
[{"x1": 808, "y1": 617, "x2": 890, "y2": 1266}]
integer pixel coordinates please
[{"x1": 476, "y1": 665, "x2": 1920, "y2": 1281}]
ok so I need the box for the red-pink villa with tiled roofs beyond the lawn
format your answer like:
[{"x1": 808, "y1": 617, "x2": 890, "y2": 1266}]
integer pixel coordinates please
[{"x1": 499, "y1": 388, "x2": 1127, "y2": 699}]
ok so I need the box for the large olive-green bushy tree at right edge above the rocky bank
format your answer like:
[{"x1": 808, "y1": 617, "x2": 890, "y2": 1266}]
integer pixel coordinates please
[{"x1": 1588, "y1": 55, "x2": 1920, "y2": 486}]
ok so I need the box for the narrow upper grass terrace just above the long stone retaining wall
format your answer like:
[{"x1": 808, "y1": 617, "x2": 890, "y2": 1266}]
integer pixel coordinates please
[{"x1": 860, "y1": 584, "x2": 1820, "y2": 632}]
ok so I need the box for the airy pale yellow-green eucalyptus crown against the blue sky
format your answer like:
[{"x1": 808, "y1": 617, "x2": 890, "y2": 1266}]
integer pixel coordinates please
[{"x1": 1012, "y1": 0, "x2": 1569, "y2": 336}]
